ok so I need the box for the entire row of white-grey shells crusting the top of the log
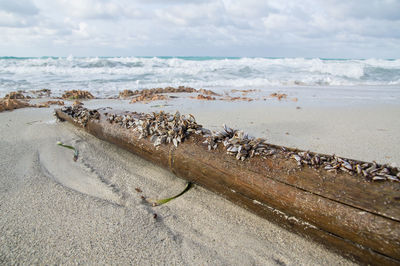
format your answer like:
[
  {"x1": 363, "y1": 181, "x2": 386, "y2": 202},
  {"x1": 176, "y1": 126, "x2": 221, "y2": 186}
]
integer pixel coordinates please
[{"x1": 61, "y1": 106, "x2": 400, "y2": 182}]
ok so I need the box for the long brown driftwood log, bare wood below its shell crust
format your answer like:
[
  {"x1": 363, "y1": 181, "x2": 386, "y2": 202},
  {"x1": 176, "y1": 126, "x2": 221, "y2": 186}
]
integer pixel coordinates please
[{"x1": 56, "y1": 109, "x2": 400, "y2": 265}]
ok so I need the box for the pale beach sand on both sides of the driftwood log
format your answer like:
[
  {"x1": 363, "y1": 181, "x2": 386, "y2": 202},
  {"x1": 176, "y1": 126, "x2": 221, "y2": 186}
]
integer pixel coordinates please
[{"x1": 0, "y1": 99, "x2": 400, "y2": 265}]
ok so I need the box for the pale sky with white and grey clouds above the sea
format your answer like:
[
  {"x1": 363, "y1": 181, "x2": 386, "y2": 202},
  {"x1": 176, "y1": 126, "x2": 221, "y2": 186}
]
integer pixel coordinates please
[{"x1": 0, "y1": 0, "x2": 400, "y2": 58}]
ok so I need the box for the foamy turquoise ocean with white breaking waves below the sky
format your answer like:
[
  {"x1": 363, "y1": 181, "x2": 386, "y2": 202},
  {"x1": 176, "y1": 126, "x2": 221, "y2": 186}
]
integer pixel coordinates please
[{"x1": 0, "y1": 56, "x2": 400, "y2": 102}]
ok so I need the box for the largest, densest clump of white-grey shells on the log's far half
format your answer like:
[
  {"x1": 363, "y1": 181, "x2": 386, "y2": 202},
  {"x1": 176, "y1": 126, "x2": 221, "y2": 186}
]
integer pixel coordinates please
[{"x1": 107, "y1": 111, "x2": 203, "y2": 147}]
